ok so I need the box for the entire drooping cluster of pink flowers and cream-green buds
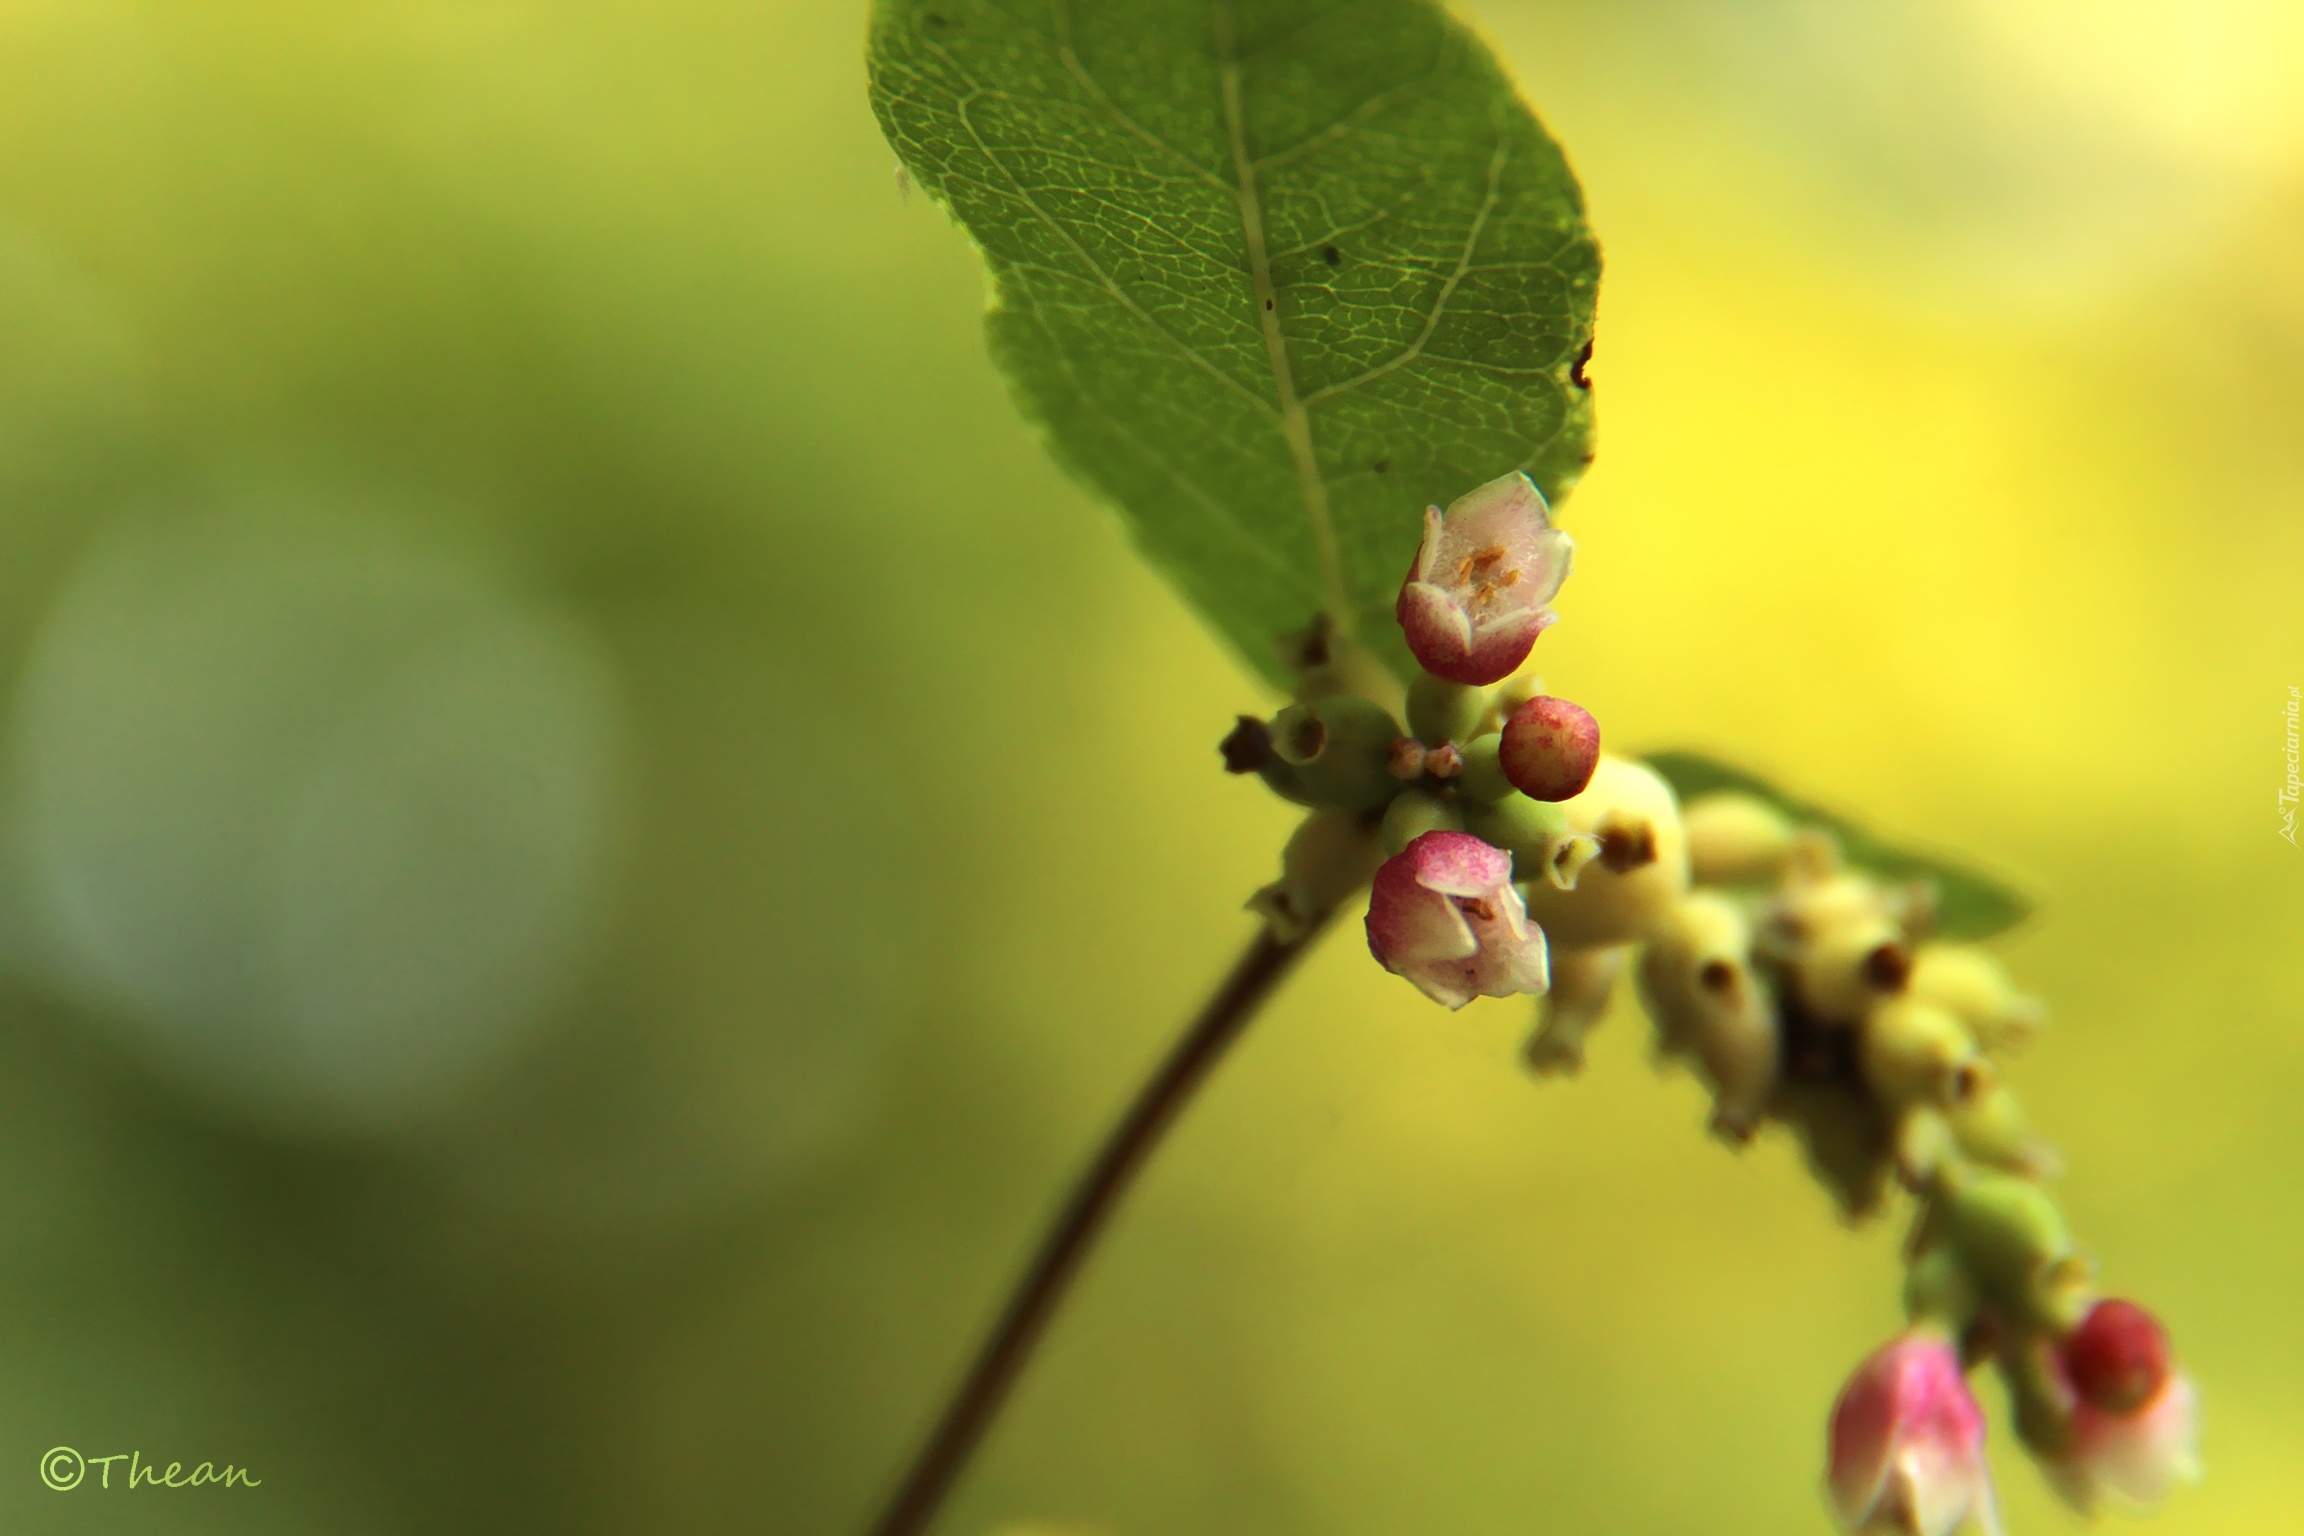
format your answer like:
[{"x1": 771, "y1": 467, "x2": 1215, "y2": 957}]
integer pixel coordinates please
[{"x1": 1221, "y1": 474, "x2": 2196, "y2": 1536}]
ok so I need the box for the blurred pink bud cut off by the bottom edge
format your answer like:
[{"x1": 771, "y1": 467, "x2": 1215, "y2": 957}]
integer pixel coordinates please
[{"x1": 1825, "y1": 1329, "x2": 2000, "y2": 1536}]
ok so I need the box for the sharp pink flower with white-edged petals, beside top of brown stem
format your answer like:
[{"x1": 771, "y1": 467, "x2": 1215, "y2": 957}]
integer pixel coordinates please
[{"x1": 1369, "y1": 831, "x2": 1546, "y2": 1009}]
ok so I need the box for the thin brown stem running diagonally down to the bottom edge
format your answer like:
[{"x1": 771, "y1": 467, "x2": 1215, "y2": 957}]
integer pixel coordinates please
[{"x1": 871, "y1": 923, "x2": 1325, "y2": 1536}]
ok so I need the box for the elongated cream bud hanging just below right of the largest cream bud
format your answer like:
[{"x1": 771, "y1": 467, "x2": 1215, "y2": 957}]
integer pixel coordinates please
[{"x1": 1640, "y1": 891, "x2": 1783, "y2": 1142}]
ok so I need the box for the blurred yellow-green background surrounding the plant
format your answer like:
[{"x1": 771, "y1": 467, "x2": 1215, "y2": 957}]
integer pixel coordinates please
[{"x1": 0, "y1": 0, "x2": 2304, "y2": 1536}]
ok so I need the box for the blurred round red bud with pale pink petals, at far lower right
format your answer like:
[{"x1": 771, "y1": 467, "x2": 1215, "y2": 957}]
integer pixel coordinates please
[{"x1": 2048, "y1": 1301, "x2": 2200, "y2": 1511}]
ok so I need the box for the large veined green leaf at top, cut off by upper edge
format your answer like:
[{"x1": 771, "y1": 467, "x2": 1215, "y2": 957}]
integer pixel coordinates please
[{"x1": 871, "y1": 0, "x2": 1599, "y2": 682}]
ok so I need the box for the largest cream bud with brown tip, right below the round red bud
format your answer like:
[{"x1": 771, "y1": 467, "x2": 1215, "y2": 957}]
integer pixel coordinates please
[{"x1": 1528, "y1": 758, "x2": 1689, "y2": 949}]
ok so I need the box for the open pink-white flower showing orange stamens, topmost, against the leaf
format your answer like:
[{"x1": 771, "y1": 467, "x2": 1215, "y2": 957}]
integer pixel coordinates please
[{"x1": 1394, "y1": 472, "x2": 1576, "y2": 686}]
